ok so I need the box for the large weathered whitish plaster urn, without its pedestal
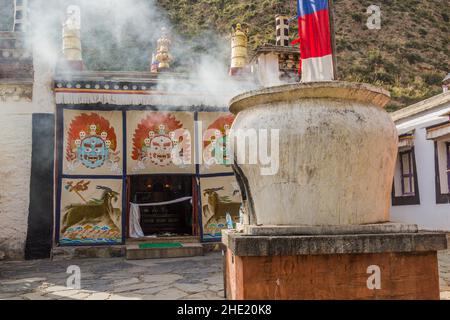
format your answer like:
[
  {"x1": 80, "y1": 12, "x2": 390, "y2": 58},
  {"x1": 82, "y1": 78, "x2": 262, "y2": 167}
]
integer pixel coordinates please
[{"x1": 231, "y1": 83, "x2": 397, "y2": 225}]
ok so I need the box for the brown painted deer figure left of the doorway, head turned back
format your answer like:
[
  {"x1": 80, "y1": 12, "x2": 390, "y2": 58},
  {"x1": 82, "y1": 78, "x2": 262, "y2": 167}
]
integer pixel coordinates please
[{"x1": 61, "y1": 186, "x2": 120, "y2": 233}]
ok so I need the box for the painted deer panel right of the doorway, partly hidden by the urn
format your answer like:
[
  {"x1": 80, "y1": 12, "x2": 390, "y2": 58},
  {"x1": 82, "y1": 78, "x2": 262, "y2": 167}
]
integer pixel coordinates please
[{"x1": 200, "y1": 176, "x2": 242, "y2": 240}]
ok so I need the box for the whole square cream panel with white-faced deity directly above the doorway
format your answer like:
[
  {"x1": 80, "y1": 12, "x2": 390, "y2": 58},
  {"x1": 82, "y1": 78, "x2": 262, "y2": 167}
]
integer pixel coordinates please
[{"x1": 127, "y1": 111, "x2": 195, "y2": 174}]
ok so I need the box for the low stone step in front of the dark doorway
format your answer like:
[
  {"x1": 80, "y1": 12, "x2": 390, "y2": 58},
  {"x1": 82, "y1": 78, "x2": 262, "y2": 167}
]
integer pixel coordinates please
[{"x1": 126, "y1": 243, "x2": 203, "y2": 260}]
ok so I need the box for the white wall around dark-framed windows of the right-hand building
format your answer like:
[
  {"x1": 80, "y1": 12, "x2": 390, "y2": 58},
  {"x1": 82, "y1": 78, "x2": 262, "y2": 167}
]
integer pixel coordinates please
[{"x1": 391, "y1": 105, "x2": 450, "y2": 231}]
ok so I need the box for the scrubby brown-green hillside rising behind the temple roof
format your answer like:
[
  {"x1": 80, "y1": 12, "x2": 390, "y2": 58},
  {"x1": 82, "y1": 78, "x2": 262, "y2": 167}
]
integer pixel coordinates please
[{"x1": 0, "y1": 0, "x2": 450, "y2": 110}]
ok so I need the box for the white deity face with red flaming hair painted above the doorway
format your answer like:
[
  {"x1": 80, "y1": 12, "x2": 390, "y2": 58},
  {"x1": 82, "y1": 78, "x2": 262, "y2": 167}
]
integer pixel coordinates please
[{"x1": 132, "y1": 113, "x2": 191, "y2": 171}]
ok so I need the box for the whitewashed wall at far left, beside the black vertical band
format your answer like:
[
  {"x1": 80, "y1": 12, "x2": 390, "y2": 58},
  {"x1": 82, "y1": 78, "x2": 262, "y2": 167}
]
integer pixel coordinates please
[{"x1": 0, "y1": 50, "x2": 55, "y2": 260}]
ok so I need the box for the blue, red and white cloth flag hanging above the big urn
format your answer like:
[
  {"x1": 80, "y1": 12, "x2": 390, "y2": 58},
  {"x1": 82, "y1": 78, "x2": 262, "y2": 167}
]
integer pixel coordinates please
[{"x1": 295, "y1": 0, "x2": 334, "y2": 82}]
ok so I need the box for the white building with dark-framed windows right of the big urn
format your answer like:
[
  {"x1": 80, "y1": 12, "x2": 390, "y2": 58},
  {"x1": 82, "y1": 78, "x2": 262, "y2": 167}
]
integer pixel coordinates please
[{"x1": 391, "y1": 82, "x2": 450, "y2": 231}]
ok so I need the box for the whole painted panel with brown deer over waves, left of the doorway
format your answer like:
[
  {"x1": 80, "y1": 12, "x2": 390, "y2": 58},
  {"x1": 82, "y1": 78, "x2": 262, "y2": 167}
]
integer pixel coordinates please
[{"x1": 59, "y1": 179, "x2": 122, "y2": 245}]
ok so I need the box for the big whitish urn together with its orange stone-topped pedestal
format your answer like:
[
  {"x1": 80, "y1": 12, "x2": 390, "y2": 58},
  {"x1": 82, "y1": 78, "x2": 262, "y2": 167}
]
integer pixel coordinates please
[{"x1": 223, "y1": 81, "x2": 447, "y2": 299}]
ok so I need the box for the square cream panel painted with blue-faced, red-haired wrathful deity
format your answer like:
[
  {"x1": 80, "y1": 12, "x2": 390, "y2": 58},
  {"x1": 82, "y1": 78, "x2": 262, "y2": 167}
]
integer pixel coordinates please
[{"x1": 63, "y1": 110, "x2": 123, "y2": 175}]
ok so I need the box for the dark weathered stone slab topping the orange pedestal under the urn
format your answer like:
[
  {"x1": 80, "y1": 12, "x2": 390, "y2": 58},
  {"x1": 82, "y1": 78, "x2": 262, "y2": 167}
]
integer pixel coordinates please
[{"x1": 222, "y1": 230, "x2": 447, "y2": 256}]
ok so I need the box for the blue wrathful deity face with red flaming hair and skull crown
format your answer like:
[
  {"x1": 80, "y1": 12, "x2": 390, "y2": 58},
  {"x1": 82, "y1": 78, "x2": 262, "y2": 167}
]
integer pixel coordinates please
[{"x1": 66, "y1": 113, "x2": 121, "y2": 174}]
